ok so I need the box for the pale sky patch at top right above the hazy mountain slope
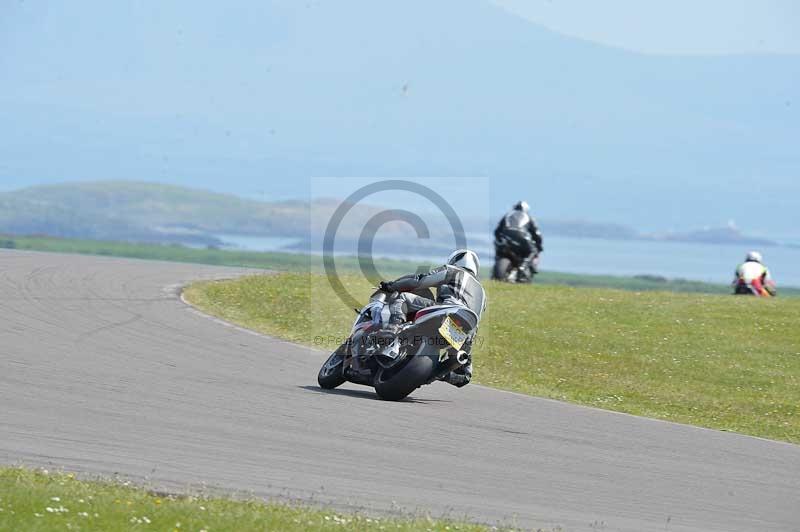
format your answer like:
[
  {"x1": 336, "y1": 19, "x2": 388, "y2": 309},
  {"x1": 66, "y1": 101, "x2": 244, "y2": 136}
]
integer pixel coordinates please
[{"x1": 493, "y1": 0, "x2": 800, "y2": 54}]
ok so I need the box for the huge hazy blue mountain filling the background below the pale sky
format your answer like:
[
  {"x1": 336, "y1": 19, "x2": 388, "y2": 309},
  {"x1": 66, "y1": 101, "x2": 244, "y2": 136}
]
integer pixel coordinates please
[{"x1": 0, "y1": 0, "x2": 800, "y2": 233}]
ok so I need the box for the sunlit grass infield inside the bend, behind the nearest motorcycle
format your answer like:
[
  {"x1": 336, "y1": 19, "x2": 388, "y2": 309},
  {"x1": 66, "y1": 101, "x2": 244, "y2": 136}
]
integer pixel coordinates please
[{"x1": 186, "y1": 273, "x2": 800, "y2": 443}]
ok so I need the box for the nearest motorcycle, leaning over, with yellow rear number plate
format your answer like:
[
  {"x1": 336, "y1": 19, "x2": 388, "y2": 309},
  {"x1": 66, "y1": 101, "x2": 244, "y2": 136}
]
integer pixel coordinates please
[{"x1": 317, "y1": 284, "x2": 479, "y2": 401}]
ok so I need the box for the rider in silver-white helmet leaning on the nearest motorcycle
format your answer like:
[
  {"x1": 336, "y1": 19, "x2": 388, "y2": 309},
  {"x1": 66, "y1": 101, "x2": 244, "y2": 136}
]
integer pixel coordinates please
[{"x1": 380, "y1": 249, "x2": 486, "y2": 388}]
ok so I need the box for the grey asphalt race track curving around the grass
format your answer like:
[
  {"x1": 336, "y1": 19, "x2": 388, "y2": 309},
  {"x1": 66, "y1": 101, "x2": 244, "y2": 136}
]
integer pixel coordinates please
[{"x1": 0, "y1": 251, "x2": 800, "y2": 532}]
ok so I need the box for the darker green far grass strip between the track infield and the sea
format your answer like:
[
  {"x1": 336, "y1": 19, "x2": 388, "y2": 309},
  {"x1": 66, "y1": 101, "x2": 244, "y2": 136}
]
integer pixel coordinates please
[{"x1": 0, "y1": 235, "x2": 800, "y2": 296}]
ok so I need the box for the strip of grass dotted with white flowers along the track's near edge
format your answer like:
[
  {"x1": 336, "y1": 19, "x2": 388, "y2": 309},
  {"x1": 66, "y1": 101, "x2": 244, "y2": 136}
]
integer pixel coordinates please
[{"x1": 0, "y1": 468, "x2": 494, "y2": 532}]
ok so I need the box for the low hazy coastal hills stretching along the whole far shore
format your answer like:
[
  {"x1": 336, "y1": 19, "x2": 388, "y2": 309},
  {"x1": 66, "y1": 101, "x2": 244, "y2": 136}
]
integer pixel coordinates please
[{"x1": 0, "y1": 181, "x2": 774, "y2": 249}]
